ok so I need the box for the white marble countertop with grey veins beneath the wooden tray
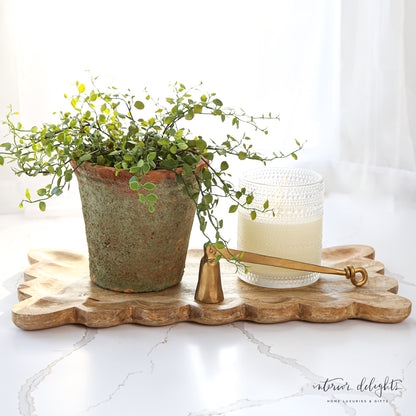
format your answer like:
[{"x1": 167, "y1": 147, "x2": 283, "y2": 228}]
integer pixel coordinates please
[{"x1": 0, "y1": 189, "x2": 416, "y2": 416}]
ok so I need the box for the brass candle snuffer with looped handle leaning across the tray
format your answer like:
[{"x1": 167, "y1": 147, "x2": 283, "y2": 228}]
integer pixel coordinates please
[{"x1": 195, "y1": 245, "x2": 368, "y2": 303}]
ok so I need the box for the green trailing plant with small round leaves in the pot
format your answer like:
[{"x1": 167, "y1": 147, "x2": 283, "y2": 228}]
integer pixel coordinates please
[{"x1": 0, "y1": 79, "x2": 302, "y2": 254}]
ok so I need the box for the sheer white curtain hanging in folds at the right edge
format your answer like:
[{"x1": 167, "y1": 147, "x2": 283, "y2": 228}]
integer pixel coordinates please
[{"x1": 326, "y1": 0, "x2": 416, "y2": 203}]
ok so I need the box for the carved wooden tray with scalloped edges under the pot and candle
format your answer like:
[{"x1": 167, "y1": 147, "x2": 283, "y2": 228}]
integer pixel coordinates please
[{"x1": 12, "y1": 245, "x2": 411, "y2": 329}]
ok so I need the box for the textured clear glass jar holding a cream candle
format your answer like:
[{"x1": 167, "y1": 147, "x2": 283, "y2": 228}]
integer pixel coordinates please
[{"x1": 237, "y1": 168, "x2": 324, "y2": 288}]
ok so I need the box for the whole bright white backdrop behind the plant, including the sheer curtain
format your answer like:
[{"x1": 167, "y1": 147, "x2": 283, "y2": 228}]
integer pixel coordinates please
[{"x1": 0, "y1": 0, "x2": 416, "y2": 215}]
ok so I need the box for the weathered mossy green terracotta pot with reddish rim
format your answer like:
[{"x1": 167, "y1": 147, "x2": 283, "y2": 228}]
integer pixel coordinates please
[{"x1": 71, "y1": 162, "x2": 203, "y2": 292}]
